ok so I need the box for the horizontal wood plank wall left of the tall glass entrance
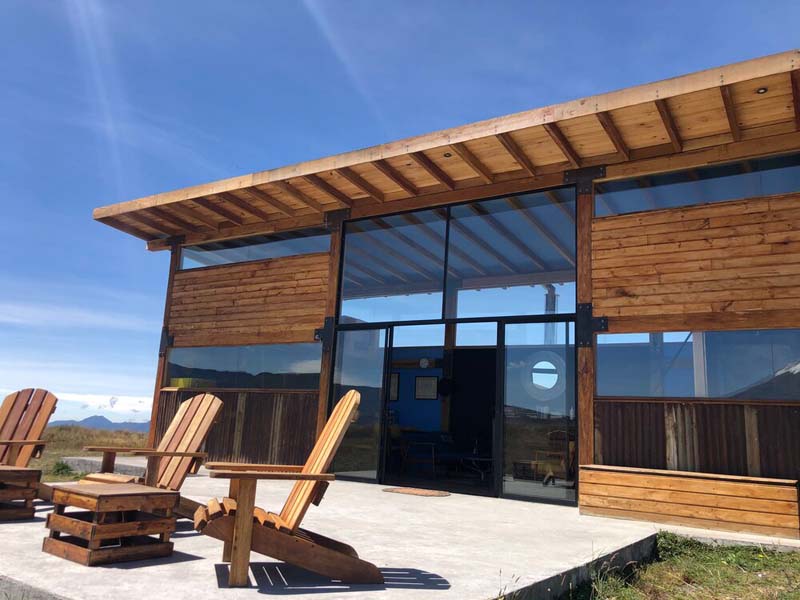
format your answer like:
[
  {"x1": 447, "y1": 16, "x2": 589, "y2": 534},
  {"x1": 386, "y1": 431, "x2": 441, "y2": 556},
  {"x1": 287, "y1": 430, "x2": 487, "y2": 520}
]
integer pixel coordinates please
[{"x1": 168, "y1": 252, "x2": 329, "y2": 346}]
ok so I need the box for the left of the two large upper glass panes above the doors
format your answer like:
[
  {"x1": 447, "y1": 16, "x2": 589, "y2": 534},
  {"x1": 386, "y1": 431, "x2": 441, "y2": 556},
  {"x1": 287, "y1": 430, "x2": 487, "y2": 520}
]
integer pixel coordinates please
[{"x1": 341, "y1": 210, "x2": 447, "y2": 323}]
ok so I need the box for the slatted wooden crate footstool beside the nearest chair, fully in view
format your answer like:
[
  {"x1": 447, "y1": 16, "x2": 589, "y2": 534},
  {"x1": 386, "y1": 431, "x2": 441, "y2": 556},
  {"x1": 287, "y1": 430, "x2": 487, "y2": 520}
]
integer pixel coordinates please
[{"x1": 42, "y1": 483, "x2": 179, "y2": 566}]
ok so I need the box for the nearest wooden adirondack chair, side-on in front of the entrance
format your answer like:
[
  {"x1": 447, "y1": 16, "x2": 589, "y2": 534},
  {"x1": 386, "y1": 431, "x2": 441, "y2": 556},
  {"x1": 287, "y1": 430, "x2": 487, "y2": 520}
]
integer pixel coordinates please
[{"x1": 194, "y1": 390, "x2": 383, "y2": 586}]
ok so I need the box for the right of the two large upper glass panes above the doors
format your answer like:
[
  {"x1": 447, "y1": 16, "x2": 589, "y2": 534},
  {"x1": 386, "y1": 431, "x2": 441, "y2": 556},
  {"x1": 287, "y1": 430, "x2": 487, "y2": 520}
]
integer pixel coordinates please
[{"x1": 447, "y1": 188, "x2": 575, "y2": 318}]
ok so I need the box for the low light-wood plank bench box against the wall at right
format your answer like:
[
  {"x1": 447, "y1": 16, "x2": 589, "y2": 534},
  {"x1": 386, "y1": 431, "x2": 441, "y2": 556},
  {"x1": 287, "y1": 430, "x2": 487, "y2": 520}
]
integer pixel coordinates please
[{"x1": 580, "y1": 465, "x2": 800, "y2": 538}]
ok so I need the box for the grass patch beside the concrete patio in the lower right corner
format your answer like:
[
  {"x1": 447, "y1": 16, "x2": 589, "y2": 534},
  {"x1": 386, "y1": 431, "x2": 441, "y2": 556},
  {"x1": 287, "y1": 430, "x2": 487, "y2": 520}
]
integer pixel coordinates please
[{"x1": 563, "y1": 533, "x2": 800, "y2": 600}]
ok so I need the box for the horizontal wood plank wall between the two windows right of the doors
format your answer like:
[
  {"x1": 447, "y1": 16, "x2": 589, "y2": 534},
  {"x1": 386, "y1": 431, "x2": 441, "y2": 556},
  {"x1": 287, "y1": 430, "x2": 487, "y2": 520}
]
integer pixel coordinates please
[{"x1": 592, "y1": 193, "x2": 800, "y2": 331}]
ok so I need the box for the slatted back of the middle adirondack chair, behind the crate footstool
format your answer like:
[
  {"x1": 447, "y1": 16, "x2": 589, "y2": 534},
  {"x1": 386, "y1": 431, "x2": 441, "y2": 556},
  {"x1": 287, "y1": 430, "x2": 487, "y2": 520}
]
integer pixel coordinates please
[{"x1": 156, "y1": 394, "x2": 222, "y2": 491}]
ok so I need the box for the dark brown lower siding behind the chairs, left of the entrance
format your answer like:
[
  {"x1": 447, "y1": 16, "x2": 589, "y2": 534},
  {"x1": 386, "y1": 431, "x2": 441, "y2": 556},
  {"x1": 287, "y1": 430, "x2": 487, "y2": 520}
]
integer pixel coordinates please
[{"x1": 155, "y1": 388, "x2": 319, "y2": 465}]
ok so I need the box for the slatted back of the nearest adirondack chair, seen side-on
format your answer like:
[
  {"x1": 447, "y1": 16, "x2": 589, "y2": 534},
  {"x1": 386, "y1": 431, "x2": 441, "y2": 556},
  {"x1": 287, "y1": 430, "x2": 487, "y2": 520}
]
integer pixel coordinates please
[{"x1": 280, "y1": 390, "x2": 361, "y2": 531}]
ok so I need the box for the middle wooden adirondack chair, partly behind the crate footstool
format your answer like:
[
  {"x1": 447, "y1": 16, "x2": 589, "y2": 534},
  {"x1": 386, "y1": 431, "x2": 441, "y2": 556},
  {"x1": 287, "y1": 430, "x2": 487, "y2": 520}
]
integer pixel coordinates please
[{"x1": 81, "y1": 394, "x2": 222, "y2": 519}]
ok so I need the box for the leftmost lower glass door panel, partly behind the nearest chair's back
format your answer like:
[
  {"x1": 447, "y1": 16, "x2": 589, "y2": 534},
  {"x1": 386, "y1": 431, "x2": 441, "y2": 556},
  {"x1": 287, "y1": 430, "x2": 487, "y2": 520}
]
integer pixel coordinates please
[{"x1": 333, "y1": 329, "x2": 386, "y2": 480}]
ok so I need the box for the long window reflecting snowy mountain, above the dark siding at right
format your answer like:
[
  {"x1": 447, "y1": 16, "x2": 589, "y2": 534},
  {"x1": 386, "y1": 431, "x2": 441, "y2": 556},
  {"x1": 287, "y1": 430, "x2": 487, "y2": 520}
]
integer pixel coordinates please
[{"x1": 597, "y1": 329, "x2": 800, "y2": 401}]
